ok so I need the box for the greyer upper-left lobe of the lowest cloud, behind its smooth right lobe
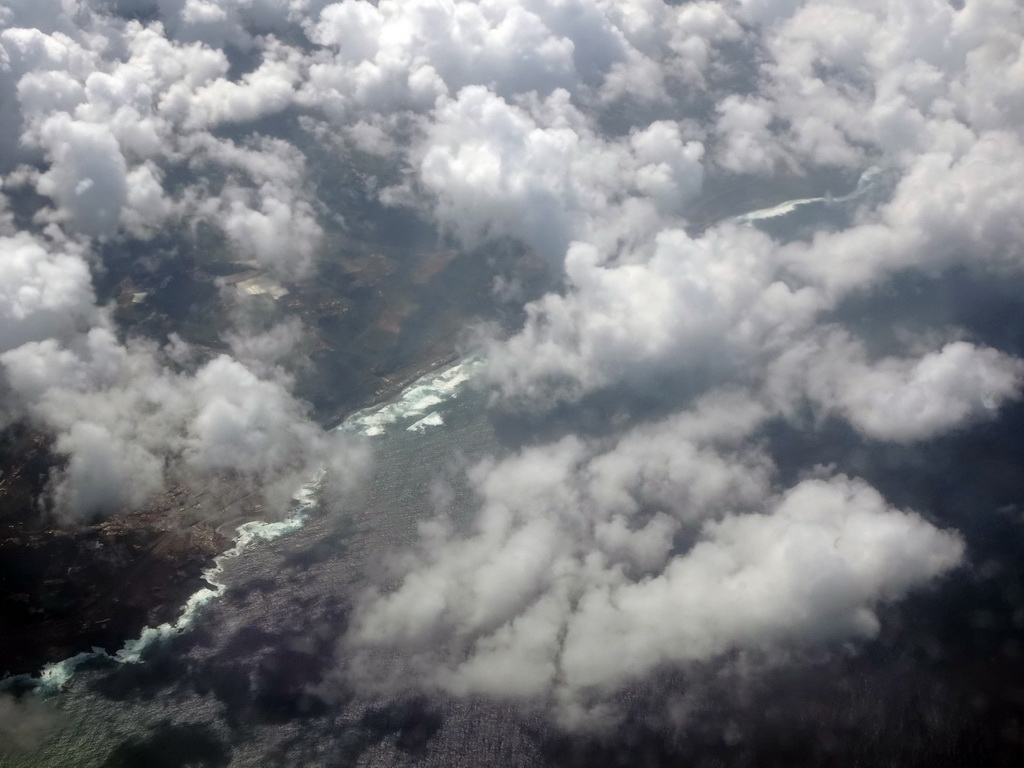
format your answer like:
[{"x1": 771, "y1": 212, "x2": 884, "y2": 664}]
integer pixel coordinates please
[{"x1": 359, "y1": 395, "x2": 770, "y2": 655}]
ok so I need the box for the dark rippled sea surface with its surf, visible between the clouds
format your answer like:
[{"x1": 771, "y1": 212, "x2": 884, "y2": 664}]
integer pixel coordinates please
[{"x1": 6, "y1": 174, "x2": 1024, "y2": 768}]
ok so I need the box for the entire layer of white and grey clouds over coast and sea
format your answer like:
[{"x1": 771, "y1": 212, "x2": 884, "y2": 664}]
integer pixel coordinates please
[{"x1": 0, "y1": 0, "x2": 1024, "y2": 723}]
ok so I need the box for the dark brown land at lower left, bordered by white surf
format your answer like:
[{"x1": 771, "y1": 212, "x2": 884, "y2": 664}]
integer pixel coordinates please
[{"x1": 0, "y1": 488, "x2": 229, "y2": 676}]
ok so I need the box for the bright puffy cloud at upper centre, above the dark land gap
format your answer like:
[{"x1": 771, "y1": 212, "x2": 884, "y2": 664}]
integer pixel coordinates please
[{"x1": 385, "y1": 86, "x2": 703, "y2": 262}]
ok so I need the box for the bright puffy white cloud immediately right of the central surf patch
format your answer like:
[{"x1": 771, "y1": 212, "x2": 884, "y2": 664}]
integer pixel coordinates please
[{"x1": 486, "y1": 229, "x2": 823, "y2": 406}]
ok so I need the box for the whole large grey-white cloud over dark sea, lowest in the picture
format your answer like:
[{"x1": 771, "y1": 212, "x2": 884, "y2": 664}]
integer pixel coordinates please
[{"x1": 347, "y1": 393, "x2": 964, "y2": 724}]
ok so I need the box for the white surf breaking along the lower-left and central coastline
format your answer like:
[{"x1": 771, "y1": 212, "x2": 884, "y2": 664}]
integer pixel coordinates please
[{"x1": 11, "y1": 358, "x2": 482, "y2": 693}]
